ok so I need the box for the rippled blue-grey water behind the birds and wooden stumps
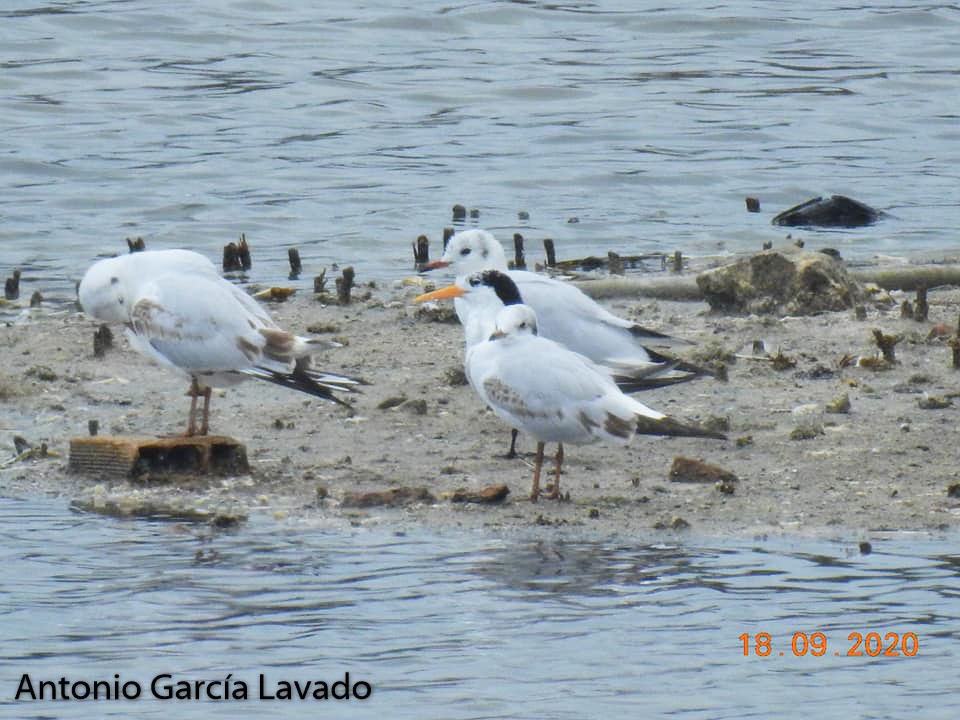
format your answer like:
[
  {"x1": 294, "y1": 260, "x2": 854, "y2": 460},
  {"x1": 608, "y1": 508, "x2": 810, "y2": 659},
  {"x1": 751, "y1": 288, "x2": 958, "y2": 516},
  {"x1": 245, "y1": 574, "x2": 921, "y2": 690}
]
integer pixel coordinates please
[{"x1": 0, "y1": 0, "x2": 960, "y2": 304}]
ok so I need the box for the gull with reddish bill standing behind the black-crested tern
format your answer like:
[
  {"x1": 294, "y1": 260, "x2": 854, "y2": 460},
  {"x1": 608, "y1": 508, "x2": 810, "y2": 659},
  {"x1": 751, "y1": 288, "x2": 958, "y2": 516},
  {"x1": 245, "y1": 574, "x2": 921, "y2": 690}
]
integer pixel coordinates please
[{"x1": 424, "y1": 229, "x2": 708, "y2": 382}]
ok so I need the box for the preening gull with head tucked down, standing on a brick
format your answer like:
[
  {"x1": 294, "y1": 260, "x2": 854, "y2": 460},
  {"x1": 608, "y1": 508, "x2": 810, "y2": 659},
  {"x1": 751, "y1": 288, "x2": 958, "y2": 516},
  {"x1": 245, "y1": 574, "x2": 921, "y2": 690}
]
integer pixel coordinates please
[{"x1": 78, "y1": 250, "x2": 363, "y2": 436}]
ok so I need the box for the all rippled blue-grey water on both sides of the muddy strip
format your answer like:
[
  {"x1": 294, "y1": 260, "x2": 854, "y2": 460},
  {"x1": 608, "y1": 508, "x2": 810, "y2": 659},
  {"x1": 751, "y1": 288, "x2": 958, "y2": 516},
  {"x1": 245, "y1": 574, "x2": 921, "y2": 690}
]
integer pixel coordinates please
[{"x1": 0, "y1": 5, "x2": 960, "y2": 720}]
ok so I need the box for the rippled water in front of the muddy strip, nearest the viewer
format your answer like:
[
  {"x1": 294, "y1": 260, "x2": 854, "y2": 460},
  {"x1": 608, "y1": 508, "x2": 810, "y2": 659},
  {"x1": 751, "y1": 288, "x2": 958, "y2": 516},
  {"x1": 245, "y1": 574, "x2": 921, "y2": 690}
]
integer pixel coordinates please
[{"x1": 0, "y1": 499, "x2": 960, "y2": 720}]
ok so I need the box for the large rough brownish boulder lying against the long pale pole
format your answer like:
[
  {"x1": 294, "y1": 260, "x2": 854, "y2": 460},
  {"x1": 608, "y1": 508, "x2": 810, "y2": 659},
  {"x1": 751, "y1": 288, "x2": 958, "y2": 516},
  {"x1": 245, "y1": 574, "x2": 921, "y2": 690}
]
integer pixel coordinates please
[{"x1": 697, "y1": 250, "x2": 861, "y2": 315}]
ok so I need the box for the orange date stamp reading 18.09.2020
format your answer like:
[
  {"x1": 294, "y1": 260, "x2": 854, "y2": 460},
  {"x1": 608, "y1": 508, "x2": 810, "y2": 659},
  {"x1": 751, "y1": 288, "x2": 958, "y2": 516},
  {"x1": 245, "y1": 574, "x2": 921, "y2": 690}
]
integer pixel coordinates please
[{"x1": 739, "y1": 632, "x2": 920, "y2": 657}]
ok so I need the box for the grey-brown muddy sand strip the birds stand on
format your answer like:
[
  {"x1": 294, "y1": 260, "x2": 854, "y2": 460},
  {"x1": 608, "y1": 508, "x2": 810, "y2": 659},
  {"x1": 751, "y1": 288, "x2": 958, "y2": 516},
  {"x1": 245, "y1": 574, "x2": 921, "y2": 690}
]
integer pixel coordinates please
[{"x1": 0, "y1": 272, "x2": 960, "y2": 536}]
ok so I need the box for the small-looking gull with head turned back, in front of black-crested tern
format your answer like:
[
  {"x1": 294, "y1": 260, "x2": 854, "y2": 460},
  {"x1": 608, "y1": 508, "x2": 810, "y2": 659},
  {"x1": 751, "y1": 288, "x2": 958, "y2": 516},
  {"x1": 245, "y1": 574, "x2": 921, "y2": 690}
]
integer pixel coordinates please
[{"x1": 466, "y1": 304, "x2": 726, "y2": 502}]
